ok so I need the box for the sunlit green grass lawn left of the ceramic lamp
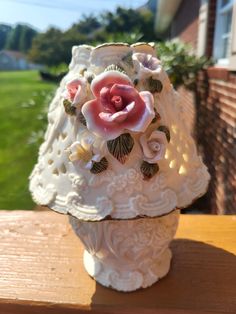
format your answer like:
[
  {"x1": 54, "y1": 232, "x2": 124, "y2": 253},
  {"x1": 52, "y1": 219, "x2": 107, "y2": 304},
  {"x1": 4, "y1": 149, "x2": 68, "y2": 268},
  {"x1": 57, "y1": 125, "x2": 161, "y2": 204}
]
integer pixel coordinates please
[{"x1": 0, "y1": 71, "x2": 56, "y2": 209}]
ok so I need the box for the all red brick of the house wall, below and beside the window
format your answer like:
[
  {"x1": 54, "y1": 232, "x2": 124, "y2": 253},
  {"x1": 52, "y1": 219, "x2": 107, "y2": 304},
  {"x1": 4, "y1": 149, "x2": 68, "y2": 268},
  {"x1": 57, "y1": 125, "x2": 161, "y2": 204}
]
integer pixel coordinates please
[{"x1": 167, "y1": 0, "x2": 236, "y2": 214}]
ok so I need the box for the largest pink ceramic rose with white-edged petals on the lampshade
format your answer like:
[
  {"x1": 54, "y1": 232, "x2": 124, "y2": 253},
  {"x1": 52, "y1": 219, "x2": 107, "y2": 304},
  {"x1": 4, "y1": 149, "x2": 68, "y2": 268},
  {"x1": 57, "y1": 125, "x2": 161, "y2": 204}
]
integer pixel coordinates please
[{"x1": 82, "y1": 71, "x2": 155, "y2": 140}]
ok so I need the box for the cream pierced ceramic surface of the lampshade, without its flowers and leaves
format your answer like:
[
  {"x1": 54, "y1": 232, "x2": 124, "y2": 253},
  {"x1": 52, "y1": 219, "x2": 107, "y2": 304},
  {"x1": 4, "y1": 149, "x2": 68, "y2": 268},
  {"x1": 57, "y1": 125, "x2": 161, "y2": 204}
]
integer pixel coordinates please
[{"x1": 30, "y1": 44, "x2": 209, "y2": 220}]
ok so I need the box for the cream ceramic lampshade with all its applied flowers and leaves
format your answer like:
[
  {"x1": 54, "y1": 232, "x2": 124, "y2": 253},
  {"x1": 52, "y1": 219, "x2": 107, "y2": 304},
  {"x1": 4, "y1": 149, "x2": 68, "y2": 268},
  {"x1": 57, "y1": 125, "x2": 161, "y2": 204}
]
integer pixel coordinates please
[{"x1": 30, "y1": 43, "x2": 209, "y2": 221}]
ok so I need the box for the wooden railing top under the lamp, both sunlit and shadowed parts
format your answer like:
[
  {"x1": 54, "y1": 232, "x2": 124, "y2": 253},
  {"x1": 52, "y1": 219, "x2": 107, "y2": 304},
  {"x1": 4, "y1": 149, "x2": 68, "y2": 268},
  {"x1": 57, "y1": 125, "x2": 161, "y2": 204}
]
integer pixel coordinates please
[{"x1": 0, "y1": 211, "x2": 236, "y2": 314}]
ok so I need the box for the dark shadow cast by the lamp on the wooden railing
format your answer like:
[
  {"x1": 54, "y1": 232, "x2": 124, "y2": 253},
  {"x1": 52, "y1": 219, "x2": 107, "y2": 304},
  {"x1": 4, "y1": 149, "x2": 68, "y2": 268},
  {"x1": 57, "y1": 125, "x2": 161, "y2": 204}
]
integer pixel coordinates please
[{"x1": 91, "y1": 239, "x2": 236, "y2": 314}]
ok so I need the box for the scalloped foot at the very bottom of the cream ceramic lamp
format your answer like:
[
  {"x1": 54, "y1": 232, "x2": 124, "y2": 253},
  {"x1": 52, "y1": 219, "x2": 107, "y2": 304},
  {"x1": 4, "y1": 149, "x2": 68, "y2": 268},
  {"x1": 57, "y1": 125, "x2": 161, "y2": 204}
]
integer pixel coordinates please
[{"x1": 84, "y1": 248, "x2": 172, "y2": 292}]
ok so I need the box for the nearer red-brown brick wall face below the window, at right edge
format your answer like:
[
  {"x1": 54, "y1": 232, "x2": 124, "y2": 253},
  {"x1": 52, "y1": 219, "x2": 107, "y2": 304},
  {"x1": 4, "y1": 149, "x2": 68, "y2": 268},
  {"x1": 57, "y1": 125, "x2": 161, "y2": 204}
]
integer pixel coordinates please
[{"x1": 196, "y1": 67, "x2": 236, "y2": 214}]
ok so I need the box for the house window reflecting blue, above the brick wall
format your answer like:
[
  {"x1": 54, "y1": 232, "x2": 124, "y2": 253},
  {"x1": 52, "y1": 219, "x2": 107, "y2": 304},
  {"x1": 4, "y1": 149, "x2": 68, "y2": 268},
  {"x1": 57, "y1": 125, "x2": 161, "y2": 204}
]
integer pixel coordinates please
[{"x1": 213, "y1": 0, "x2": 234, "y2": 65}]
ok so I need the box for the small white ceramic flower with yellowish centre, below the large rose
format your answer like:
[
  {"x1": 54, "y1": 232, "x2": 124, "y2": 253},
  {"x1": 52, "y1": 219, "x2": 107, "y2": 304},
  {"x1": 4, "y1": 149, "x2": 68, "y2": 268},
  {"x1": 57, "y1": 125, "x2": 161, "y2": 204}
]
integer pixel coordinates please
[{"x1": 69, "y1": 130, "x2": 105, "y2": 169}]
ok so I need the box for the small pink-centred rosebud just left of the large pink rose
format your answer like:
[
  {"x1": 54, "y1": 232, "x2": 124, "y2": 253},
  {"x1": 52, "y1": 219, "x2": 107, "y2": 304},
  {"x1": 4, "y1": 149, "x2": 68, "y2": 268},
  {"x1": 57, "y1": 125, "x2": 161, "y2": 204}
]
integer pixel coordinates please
[{"x1": 64, "y1": 77, "x2": 87, "y2": 106}]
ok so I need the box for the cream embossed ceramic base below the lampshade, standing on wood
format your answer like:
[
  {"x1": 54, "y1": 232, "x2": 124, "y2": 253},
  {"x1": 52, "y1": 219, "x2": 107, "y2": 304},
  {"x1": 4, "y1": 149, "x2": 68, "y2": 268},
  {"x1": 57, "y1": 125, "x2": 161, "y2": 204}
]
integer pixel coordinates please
[{"x1": 70, "y1": 211, "x2": 179, "y2": 291}]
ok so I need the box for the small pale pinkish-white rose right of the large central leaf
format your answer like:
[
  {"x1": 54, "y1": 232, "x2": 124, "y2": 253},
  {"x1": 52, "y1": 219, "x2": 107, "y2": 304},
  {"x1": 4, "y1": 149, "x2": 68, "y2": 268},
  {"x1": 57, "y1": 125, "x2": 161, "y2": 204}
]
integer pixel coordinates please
[{"x1": 140, "y1": 131, "x2": 167, "y2": 163}]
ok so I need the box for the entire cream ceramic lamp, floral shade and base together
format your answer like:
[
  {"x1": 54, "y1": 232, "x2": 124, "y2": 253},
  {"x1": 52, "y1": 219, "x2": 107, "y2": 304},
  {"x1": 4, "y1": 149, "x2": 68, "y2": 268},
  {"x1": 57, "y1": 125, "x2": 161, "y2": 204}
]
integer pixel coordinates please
[{"x1": 30, "y1": 43, "x2": 209, "y2": 291}]
